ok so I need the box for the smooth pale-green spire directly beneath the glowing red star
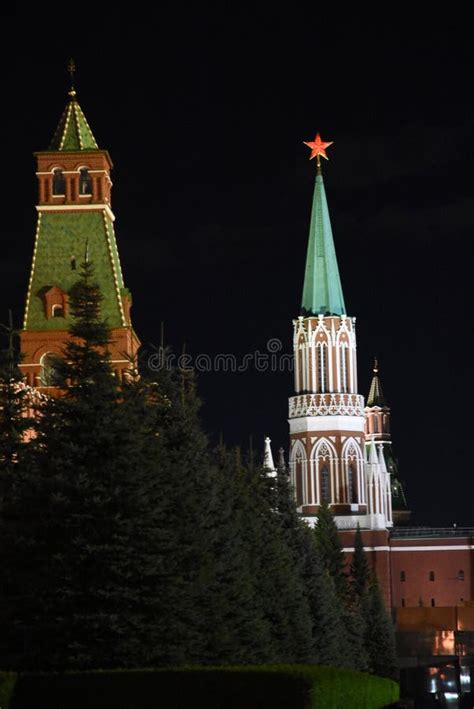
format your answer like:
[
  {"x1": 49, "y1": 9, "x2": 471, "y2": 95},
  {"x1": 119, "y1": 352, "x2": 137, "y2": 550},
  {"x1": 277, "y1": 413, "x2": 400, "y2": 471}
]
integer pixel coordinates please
[{"x1": 301, "y1": 169, "x2": 346, "y2": 315}]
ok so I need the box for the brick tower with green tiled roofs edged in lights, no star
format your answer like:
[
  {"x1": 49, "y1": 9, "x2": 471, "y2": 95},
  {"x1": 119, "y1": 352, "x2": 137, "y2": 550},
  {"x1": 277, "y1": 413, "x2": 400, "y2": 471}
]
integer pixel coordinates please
[{"x1": 20, "y1": 72, "x2": 140, "y2": 389}]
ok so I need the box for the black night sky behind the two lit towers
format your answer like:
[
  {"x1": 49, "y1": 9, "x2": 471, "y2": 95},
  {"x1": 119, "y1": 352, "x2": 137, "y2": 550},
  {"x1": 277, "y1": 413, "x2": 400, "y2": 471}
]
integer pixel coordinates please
[{"x1": 0, "y1": 8, "x2": 474, "y2": 526}]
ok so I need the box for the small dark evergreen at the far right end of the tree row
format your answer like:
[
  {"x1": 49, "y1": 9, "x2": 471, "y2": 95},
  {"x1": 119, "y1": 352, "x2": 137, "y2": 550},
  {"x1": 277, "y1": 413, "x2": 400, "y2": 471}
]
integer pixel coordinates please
[{"x1": 365, "y1": 575, "x2": 398, "y2": 680}]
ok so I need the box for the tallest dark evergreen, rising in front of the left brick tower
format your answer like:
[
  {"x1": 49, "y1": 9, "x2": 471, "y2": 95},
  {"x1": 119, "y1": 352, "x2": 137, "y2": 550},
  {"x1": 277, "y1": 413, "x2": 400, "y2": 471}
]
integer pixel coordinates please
[{"x1": 0, "y1": 262, "x2": 181, "y2": 668}]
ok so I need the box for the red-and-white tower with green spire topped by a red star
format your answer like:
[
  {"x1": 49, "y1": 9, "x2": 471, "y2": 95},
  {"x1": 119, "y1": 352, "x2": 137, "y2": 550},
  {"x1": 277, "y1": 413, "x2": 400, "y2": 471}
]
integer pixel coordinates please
[{"x1": 289, "y1": 134, "x2": 393, "y2": 530}]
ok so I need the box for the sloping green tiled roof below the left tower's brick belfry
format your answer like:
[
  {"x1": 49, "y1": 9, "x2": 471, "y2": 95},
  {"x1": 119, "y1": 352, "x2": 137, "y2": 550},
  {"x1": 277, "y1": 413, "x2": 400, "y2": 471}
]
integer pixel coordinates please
[{"x1": 25, "y1": 210, "x2": 125, "y2": 330}]
